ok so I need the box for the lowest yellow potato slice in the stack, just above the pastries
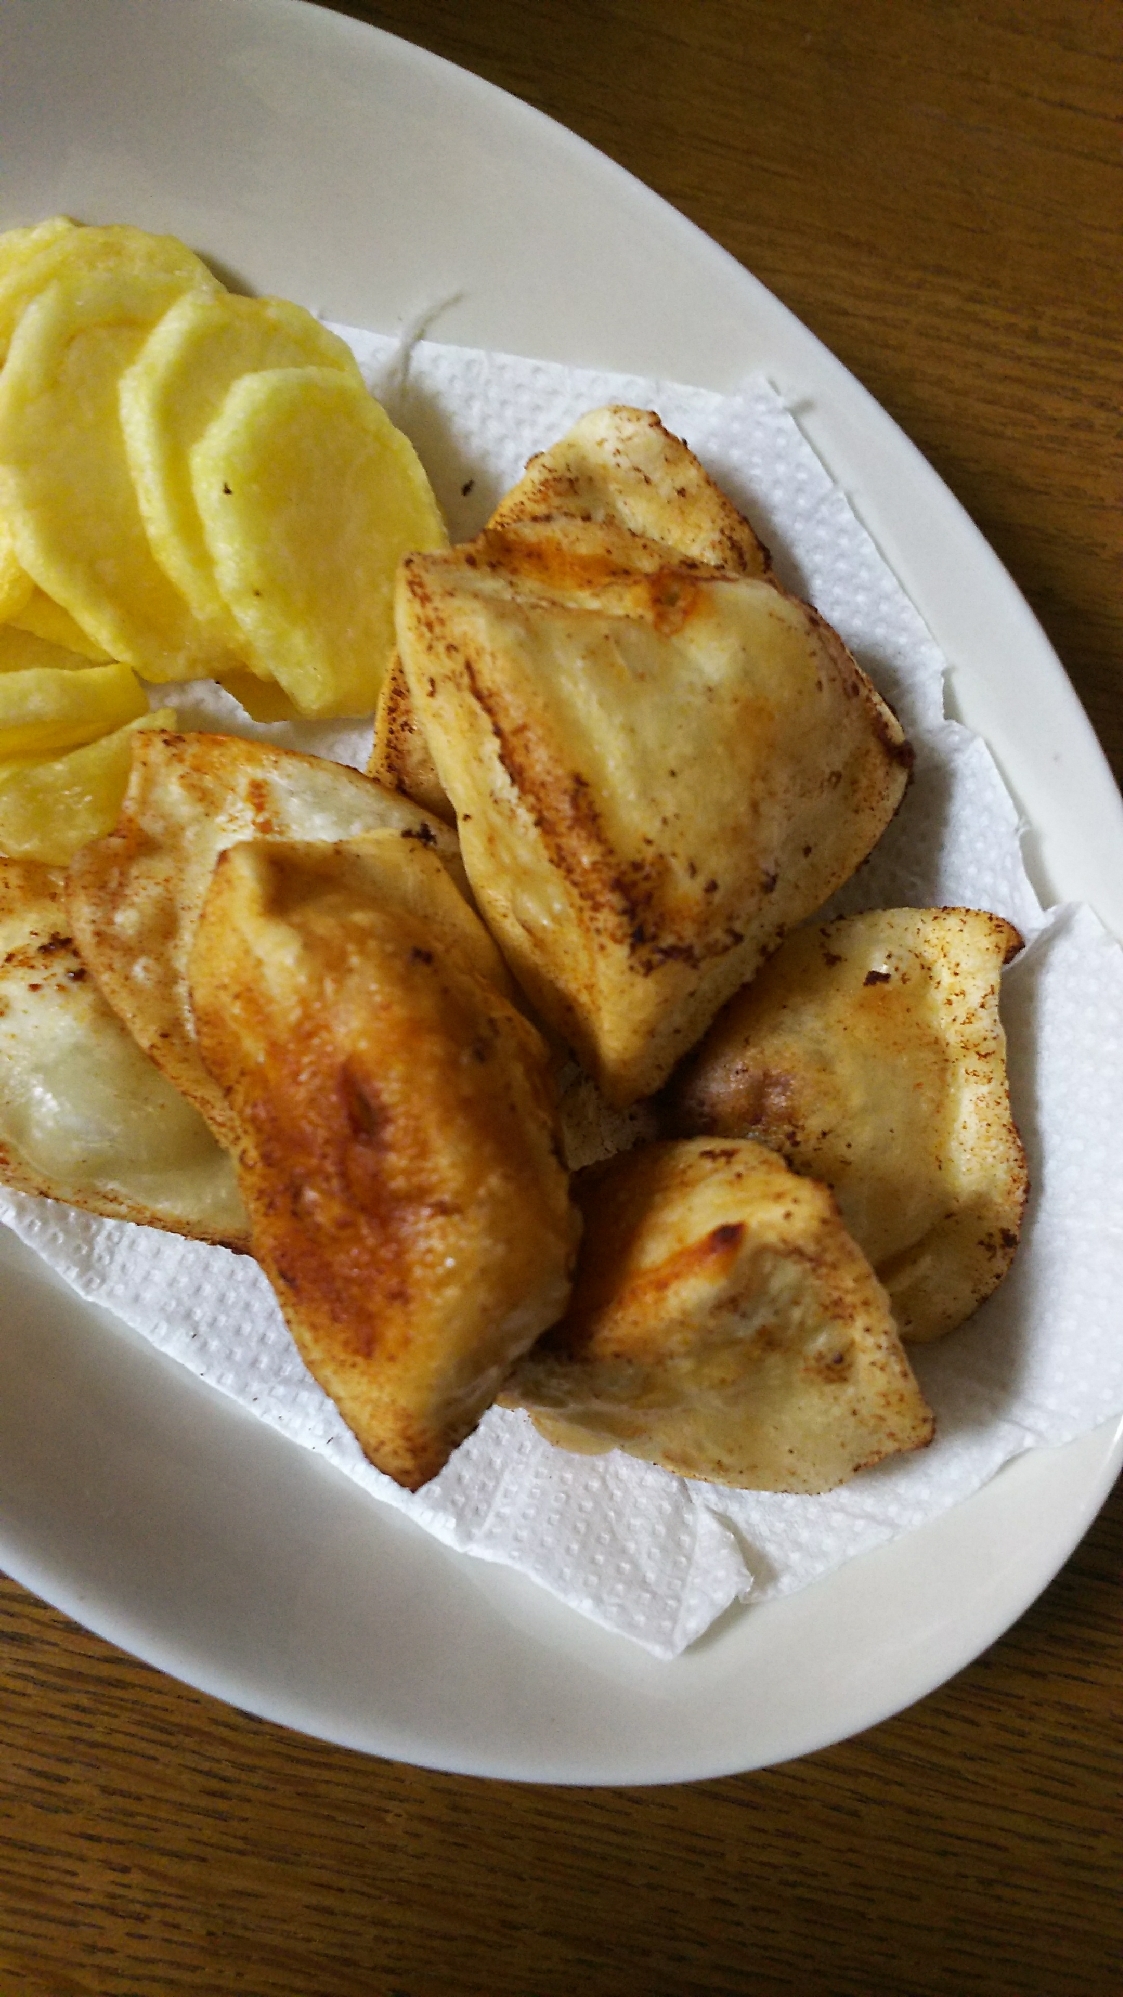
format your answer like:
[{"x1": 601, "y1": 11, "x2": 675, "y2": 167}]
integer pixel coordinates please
[{"x1": 0, "y1": 707, "x2": 176, "y2": 867}]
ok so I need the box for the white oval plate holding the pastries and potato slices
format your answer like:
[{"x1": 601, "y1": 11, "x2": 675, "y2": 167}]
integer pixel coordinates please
[{"x1": 0, "y1": 0, "x2": 1123, "y2": 1783}]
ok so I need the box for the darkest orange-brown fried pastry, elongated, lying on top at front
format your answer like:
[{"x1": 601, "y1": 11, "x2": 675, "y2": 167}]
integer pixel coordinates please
[{"x1": 192, "y1": 833, "x2": 575, "y2": 1490}]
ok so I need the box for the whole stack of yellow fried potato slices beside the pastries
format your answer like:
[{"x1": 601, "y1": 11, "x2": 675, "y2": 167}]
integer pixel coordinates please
[{"x1": 0, "y1": 218, "x2": 446, "y2": 861}]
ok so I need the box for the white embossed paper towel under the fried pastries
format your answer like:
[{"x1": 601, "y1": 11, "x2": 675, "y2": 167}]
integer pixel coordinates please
[{"x1": 0, "y1": 332, "x2": 1123, "y2": 1658}]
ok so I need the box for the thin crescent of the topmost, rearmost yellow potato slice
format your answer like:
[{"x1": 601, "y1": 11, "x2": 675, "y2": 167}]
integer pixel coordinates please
[{"x1": 0, "y1": 218, "x2": 211, "y2": 361}]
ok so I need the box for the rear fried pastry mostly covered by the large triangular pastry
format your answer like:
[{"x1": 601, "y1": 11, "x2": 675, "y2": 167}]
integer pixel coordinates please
[{"x1": 368, "y1": 405, "x2": 771, "y2": 821}]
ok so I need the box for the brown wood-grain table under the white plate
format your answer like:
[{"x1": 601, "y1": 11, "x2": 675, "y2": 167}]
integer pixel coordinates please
[{"x1": 0, "y1": 0, "x2": 1123, "y2": 1997}]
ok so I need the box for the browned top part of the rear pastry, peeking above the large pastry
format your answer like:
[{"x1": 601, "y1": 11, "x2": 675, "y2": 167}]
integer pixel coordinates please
[{"x1": 488, "y1": 403, "x2": 771, "y2": 575}]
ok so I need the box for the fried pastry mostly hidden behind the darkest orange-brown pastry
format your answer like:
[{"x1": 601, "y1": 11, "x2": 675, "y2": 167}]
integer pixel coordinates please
[{"x1": 70, "y1": 731, "x2": 460, "y2": 1148}]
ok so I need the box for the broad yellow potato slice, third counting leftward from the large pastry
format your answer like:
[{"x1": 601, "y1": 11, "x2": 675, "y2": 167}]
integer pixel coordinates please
[{"x1": 0, "y1": 266, "x2": 228, "y2": 681}]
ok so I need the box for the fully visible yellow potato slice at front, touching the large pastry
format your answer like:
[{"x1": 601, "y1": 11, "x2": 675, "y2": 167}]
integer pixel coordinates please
[{"x1": 192, "y1": 367, "x2": 448, "y2": 715}]
